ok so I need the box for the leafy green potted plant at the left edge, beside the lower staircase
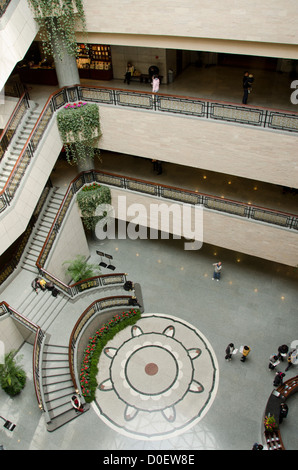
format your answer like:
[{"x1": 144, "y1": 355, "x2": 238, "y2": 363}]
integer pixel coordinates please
[{"x1": 0, "y1": 351, "x2": 26, "y2": 397}]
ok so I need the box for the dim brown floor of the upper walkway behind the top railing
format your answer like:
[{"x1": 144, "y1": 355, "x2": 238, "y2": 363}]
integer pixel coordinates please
[{"x1": 27, "y1": 65, "x2": 298, "y2": 113}]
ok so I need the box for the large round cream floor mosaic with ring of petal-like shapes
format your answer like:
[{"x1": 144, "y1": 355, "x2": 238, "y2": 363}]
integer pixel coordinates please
[{"x1": 93, "y1": 314, "x2": 218, "y2": 440}]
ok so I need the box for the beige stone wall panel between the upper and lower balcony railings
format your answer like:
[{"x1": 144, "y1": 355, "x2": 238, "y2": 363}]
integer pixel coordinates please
[{"x1": 99, "y1": 106, "x2": 298, "y2": 187}]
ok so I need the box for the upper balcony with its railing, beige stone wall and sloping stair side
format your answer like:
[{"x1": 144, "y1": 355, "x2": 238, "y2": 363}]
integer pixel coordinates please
[{"x1": 1, "y1": 75, "x2": 298, "y2": 264}]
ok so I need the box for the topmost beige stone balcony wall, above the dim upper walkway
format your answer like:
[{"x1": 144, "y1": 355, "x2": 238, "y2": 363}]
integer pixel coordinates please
[{"x1": 85, "y1": 0, "x2": 298, "y2": 44}]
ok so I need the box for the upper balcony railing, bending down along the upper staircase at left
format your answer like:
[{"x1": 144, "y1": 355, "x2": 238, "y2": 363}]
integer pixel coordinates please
[{"x1": 0, "y1": 85, "x2": 298, "y2": 218}]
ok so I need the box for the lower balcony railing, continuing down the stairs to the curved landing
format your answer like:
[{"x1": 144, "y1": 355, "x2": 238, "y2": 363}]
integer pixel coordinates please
[{"x1": 36, "y1": 170, "x2": 298, "y2": 288}]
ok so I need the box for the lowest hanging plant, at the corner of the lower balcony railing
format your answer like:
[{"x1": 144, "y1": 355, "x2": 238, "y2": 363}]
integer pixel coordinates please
[{"x1": 77, "y1": 183, "x2": 111, "y2": 230}]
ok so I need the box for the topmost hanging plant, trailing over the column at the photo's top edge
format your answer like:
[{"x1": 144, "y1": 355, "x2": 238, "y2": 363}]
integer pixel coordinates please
[{"x1": 28, "y1": 0, "x2": 86, "y2": 59}]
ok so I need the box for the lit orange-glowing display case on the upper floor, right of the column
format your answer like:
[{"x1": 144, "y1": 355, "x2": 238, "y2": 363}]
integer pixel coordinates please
[{"x1": 77, "y1": 44, "x2": 113, "y2": 80}]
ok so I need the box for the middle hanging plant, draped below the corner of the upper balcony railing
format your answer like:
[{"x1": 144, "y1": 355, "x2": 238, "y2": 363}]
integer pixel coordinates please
[{"x1": 57, "y1": 101, "x2": 101, "y2": 164}]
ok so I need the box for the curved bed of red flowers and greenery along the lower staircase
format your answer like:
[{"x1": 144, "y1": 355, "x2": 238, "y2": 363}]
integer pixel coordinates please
[{"x1": 80, "y1": 310, "x2": 141, "y2": 403}]
